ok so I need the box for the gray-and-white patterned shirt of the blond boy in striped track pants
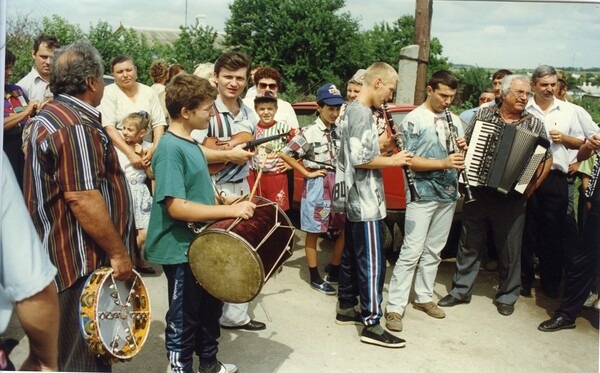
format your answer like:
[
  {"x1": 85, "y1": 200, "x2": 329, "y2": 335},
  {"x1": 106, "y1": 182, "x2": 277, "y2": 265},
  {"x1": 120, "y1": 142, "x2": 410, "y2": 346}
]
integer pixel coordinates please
[{"x1": 333, "y1": 100, "x2": 387, "y2": 222}]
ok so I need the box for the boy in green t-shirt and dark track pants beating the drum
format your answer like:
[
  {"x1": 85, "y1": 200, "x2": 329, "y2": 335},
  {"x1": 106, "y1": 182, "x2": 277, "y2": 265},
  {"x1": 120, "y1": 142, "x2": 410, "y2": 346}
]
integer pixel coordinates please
[{"x1": 144, "y1": 73, "x2": 256, "y2": 373}]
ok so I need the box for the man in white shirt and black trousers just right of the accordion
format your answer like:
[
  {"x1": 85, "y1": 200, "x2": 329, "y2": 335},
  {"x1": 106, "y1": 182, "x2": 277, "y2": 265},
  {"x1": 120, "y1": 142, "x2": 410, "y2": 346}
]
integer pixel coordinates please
[{"x1": 521, "y1": 65, "x2": 583, "y2": 298}]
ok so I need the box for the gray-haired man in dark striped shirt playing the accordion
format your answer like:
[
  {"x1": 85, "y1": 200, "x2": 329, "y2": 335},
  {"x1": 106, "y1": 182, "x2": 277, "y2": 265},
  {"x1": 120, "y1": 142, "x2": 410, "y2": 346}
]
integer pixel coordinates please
[{"x1": 438, "y1": 75, "x2": 552, "y2": 316}]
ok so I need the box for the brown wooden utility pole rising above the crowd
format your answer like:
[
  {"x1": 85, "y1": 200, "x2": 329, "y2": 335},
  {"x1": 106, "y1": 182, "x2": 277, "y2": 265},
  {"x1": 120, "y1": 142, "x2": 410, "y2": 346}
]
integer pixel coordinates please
[{"x1": 413, "y1": 0, "x2": 433, "y2": 105}]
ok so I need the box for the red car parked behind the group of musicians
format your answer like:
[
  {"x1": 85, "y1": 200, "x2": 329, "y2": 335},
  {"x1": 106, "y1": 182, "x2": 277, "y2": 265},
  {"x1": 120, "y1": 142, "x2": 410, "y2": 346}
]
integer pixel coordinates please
[{"x1": 292, "y1": 101, "x2": 462, "y2": 262}]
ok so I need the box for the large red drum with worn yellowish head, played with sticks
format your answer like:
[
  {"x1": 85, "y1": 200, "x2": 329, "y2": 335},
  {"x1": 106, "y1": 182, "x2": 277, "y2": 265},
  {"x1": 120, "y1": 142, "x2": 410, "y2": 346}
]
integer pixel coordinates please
[{"x1": 188, "y1": 197, "x2": 295, "y2": 303}]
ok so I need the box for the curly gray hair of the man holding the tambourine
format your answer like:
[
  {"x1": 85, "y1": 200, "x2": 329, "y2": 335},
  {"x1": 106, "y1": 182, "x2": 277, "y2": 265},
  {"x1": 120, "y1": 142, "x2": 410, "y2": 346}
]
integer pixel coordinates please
[{"x1": 50, "y1": 40, "x2": 104, "y2": 96}]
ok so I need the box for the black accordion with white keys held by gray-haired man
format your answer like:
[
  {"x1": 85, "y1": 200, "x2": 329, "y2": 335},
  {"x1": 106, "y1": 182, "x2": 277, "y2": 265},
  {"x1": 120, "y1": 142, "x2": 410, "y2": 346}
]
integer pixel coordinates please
[{"x1": 463, "y1": 120, "x2": 550, "y2": 194}]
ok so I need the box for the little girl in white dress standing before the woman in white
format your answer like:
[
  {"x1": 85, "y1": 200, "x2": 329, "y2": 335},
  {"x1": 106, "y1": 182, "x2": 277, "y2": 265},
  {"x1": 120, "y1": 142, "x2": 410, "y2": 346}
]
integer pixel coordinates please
[{"x1": 115, "y1": 111, "x2": 156, "y2": 274}]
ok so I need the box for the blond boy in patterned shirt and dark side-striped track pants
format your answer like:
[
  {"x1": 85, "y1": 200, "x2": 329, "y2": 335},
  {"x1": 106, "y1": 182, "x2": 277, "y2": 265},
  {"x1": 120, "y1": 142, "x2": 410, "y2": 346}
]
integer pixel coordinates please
[{"x1": 333, "y1": 62, "x2": 410, "y2": 348}]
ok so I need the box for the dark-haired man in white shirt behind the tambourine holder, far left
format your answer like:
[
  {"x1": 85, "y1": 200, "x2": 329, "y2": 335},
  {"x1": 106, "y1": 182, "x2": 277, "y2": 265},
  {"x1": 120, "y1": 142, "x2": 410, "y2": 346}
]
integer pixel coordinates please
[{"x1": 17, "y1": 34, "x2": 60, "y2": 102}]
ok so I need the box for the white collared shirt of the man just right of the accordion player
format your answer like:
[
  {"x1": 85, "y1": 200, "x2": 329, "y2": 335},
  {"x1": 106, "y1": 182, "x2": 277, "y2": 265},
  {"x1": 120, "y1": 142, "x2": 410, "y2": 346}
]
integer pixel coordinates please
[{"x1": 525, "y1": 97, "x2": 583, "y2": 174}]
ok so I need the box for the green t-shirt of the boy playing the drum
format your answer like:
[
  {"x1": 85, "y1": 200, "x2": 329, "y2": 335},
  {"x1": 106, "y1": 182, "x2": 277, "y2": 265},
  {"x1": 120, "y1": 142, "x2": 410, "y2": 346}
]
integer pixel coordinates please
[{"x1": 144, "y1": 132, "x2": 215, "y2": 264}]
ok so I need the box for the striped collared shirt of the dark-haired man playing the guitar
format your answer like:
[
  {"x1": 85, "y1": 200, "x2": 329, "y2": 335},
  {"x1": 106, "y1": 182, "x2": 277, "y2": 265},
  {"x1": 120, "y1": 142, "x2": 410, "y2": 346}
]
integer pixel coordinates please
[{"x1": 200, "y1": 95, "x2": 258, "y2": 184}]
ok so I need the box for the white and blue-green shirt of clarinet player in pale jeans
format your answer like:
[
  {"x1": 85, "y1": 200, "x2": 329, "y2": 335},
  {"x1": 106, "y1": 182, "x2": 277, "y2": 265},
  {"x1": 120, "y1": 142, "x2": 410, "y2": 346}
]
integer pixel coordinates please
[{"x1": 400, "y1": 104, "x2": 463, "y2": 202}]
